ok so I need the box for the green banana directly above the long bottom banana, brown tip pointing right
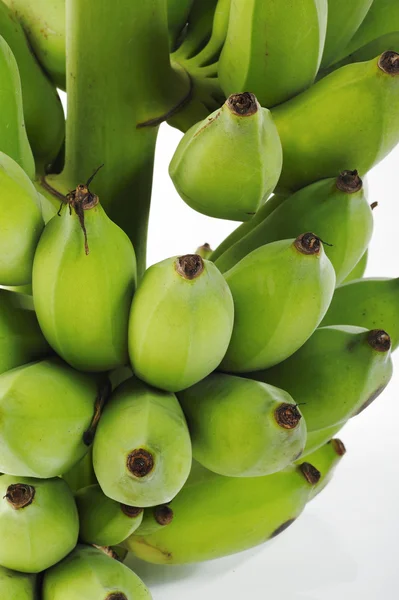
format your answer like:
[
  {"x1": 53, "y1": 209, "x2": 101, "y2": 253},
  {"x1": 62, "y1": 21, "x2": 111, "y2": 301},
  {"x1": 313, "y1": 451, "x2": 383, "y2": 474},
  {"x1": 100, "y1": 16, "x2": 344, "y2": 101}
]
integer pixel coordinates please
[{"x1": 178, "y1": 373, "x2": 306, "y2": 477}]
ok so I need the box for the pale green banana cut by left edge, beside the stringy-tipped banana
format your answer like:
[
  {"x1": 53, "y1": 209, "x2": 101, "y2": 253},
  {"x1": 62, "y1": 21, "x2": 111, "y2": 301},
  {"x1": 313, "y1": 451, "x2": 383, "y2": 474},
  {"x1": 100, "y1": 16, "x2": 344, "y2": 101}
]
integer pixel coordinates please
[{"x1": 0, "y1": 154, "x2": 44, "y2": 286}]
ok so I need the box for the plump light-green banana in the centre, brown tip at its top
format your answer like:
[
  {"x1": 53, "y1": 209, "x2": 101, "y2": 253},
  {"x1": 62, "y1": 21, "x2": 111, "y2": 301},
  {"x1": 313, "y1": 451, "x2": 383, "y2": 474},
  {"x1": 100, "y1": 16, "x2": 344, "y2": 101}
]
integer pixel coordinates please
[{"x1": 129, "y1": 254, "x2": 234, "y2": 392}]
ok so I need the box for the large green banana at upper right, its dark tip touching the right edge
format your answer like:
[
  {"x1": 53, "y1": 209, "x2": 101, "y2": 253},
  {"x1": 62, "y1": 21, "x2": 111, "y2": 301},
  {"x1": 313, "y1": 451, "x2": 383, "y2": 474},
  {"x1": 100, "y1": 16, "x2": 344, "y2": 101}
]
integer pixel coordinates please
[{"x1": 272, "y1": 51, "x2": 399, "y2": 193}]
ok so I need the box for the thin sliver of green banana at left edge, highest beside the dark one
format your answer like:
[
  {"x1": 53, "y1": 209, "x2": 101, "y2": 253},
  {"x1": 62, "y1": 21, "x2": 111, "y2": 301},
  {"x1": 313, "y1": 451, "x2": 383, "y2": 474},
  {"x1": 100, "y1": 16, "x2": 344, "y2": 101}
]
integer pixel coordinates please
[{"x1": 0, "y1": 35, "x2": 35, "y2": 179}]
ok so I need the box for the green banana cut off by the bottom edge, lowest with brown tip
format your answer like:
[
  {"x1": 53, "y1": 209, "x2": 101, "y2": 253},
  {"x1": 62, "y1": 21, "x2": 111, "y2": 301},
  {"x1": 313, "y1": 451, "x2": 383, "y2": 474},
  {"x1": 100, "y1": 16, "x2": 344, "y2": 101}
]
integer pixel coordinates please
[{"x1": 42, "y1": 545, "x2": 151, "y2": 600}]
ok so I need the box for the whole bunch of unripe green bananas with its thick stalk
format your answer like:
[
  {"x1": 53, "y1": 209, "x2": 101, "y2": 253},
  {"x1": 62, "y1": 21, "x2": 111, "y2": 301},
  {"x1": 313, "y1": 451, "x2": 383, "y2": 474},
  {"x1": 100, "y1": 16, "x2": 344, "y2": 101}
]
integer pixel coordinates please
[{"x1": 0, "y1": 0, "x2": 399, "y2": 600}]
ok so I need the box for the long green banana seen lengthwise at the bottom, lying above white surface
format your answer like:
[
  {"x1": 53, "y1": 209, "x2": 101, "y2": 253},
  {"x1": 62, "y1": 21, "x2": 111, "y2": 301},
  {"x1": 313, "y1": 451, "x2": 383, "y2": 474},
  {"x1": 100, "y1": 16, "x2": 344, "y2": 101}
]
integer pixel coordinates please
[{"x1": 123, "y1": 463, "x2": 320, "y2": 564}]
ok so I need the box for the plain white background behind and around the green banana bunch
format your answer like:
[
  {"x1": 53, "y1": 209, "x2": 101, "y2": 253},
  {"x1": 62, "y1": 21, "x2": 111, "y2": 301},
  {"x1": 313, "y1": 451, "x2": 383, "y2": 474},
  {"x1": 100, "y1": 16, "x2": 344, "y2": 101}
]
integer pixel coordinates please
[{"x1": 60, "y1": 86, "x2": 399, "y2": 600}]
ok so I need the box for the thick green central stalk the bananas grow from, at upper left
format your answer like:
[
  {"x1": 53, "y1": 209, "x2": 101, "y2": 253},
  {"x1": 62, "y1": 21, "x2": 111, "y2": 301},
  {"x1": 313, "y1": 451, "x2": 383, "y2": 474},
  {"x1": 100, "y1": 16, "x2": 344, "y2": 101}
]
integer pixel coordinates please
[{"x1": 47, "y1": 0, "x2": 191, "y2": 273}]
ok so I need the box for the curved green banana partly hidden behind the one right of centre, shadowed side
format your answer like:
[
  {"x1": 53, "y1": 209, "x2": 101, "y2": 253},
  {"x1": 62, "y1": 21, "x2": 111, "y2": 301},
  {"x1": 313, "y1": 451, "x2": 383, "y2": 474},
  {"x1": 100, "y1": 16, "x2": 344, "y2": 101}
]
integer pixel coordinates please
[{"x1": 215, "y1": 171, "x2": 373, "y2": 284}]
